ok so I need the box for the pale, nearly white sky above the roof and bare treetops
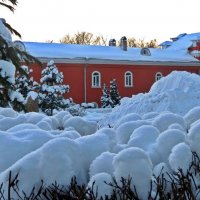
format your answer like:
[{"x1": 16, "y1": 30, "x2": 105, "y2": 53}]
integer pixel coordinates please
[{"x1": 0, "y1": 0, "x2": 200, "y2": 42}]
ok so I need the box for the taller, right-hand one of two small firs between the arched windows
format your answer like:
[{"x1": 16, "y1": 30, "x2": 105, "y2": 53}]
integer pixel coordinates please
[{"x1": 110, "y1": 79, "x2": 121, "y2": 107}]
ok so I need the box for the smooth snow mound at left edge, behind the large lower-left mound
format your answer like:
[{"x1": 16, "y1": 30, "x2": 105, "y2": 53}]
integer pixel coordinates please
[{"x1": 0, "y1": 129, "x2": 53, "y2": 172}]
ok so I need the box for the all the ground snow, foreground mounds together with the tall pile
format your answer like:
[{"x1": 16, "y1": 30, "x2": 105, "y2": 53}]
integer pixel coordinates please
[{"x1": 0, "y1": 72, "x2": 200, "y2": 199}]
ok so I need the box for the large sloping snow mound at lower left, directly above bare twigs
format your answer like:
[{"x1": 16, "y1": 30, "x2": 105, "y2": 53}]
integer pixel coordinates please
[{"x1": 0, "y1": 138, "x2": 86, "y2": 195}]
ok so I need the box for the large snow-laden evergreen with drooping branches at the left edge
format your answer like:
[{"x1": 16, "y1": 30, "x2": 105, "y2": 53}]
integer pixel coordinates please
[{"x1": 0, "y1": 0, "x2": 40, "y2": 111}]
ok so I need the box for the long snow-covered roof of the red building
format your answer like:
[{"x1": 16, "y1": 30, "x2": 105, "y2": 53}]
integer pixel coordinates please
[{"x1": 24, "y1": 33, "x2": 200, "y2": 62}]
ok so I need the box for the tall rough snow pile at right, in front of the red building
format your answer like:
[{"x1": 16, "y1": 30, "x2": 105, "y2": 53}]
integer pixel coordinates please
[{"x1": 99, "y1": 71, "x2": 200, "y2": 126}]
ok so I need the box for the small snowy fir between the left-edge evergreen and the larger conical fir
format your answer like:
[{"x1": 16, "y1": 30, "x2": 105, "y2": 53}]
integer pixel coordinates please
[{"x1": 15, "y1": 65, "x2": 39, "y2": 98}]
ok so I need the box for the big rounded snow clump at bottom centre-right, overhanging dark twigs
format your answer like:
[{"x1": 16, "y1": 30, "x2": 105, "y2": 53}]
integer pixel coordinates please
[{"x1": 113, "y1": 147, "x2": 152, "y2": 199}]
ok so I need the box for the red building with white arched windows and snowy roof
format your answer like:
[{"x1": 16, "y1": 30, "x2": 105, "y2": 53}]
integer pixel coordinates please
[{"x1": 13, "y1": 33, "x2": 200, "y2": 103}]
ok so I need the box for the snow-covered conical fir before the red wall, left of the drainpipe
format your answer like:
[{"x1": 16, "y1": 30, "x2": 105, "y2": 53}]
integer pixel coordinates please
[{"x1": 39, "y1": 61, "x2": 69, "y2": 115}]
